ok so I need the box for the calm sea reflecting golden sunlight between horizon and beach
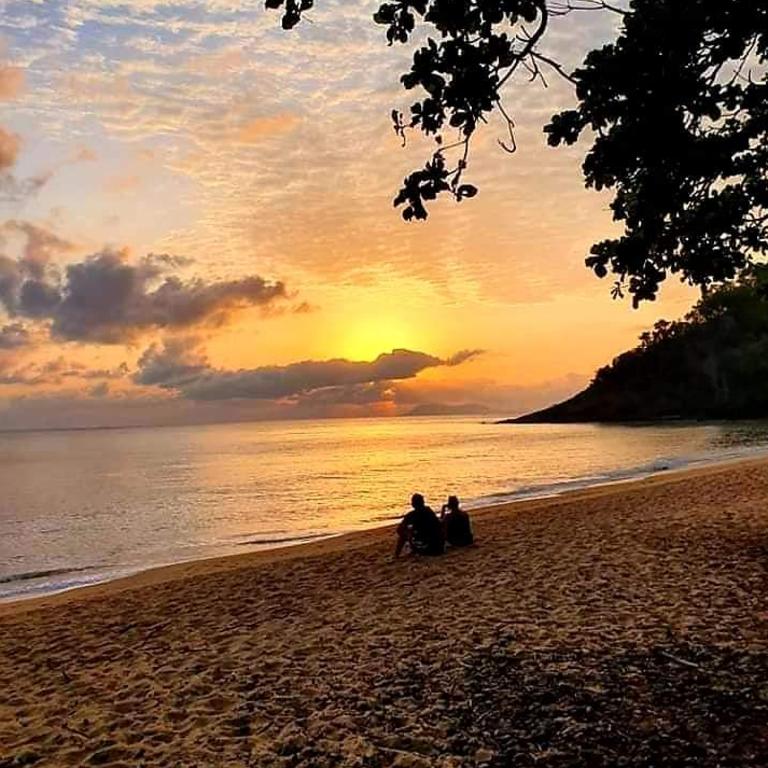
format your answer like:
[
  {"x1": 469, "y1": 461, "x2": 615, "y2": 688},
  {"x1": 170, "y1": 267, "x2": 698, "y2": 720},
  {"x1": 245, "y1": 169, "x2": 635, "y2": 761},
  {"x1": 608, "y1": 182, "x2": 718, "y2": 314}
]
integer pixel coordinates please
[{"x1": 0, "y1": 417, "x2": 768, "y2": 599}]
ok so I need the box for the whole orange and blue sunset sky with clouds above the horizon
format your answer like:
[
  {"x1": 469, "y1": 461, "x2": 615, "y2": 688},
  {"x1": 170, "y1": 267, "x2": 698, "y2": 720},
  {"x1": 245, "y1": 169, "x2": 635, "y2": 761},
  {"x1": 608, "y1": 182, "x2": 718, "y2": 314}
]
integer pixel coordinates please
[{"x1": 0, "y1": 0, "x2": 695, "y2": 429}]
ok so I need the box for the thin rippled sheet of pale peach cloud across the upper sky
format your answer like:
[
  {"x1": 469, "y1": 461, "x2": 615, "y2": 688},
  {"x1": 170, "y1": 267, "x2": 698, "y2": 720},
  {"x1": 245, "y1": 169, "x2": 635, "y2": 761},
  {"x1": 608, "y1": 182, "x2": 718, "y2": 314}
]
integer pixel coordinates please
[{"x1": 0, "y1": 0, "x2": 632, "y2": 302}]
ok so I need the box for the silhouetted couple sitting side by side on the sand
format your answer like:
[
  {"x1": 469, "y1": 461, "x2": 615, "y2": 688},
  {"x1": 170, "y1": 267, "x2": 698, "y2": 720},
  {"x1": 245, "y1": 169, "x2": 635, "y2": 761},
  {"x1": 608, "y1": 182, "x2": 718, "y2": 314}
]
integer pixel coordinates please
[{"x1": 395, "y1": 493, "x2": 474, "y2": 557}]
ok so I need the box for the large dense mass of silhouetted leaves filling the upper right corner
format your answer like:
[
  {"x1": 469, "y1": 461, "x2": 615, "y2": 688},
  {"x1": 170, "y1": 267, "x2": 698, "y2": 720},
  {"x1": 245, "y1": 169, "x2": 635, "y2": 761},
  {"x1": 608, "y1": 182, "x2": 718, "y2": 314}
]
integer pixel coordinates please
[{"x1": 545, "y1": 0, "x2": 768, "y2": 306}]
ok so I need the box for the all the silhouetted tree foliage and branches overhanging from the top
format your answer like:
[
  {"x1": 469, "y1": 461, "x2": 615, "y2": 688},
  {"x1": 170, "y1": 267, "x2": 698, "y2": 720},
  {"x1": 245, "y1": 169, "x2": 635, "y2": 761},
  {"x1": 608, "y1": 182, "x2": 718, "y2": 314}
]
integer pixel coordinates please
[{"x1": 266, "y1": 0, "x2": 768, "y2": 306}]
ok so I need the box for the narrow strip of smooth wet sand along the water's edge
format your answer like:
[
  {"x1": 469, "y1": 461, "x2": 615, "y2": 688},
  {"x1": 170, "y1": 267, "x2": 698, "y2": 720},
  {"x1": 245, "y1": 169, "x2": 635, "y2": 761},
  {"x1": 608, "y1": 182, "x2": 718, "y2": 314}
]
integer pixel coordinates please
[{"x1": 0, "y1": 448, "x2": 768, "y2": 620}]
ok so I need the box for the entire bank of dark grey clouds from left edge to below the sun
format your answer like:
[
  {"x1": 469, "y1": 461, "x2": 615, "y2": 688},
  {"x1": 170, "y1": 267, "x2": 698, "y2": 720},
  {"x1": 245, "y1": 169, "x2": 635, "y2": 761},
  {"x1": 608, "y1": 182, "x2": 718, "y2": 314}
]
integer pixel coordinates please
[{"x1": 0, "y1": 221, "x2": 492, "y2": 420}]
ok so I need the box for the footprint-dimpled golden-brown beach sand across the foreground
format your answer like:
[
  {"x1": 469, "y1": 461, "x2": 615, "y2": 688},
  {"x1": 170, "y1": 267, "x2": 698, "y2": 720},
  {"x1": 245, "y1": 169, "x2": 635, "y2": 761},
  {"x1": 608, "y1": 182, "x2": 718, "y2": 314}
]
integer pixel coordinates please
[{"x1": 0, "y1": 462, "x2": 768, "y2": 768}]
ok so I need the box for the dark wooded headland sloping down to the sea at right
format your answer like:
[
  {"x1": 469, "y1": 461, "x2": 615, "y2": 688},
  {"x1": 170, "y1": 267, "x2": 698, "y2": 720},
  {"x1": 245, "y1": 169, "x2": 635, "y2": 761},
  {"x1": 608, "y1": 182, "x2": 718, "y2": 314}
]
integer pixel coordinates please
[{"x1": 499, "y1": 265, "x2": 768, "y2": 424}]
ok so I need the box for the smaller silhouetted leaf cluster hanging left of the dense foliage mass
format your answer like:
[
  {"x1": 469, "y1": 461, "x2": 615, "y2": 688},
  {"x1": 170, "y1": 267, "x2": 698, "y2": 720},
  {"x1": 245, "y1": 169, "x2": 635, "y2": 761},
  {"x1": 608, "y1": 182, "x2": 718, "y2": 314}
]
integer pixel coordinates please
[{"x1": 374, "y1": 0, "x2": 548, "y2": 221}]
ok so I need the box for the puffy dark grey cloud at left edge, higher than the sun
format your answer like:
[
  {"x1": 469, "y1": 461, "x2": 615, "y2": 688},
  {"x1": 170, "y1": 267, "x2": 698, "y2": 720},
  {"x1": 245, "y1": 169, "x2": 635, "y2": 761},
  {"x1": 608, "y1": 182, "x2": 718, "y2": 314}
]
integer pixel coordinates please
[{"x1": 0, "y1": 250, "x2": 288, "y2": 344}]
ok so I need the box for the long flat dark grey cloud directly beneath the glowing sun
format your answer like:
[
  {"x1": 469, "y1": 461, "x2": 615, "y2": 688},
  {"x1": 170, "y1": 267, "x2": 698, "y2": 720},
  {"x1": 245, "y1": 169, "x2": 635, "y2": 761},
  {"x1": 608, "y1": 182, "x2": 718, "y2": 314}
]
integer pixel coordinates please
[{"x1": 134, "y1": 340, "x2": 477, "y2": 400}]
